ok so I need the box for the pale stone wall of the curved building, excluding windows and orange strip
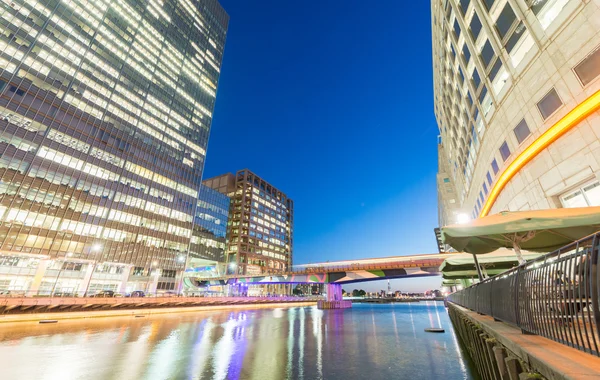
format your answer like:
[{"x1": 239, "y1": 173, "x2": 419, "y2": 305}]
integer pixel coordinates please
[{"x1": 432, "y1": 0, "x2": 600, "y2": 221}]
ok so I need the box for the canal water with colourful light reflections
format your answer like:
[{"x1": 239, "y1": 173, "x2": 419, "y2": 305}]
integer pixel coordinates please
[{"x1": 0, "y1": 301, "x2": 478, "y2": 380}]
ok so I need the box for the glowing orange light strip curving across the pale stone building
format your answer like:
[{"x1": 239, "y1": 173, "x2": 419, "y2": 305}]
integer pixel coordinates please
[{"x1": 479, "y1": 91, "x2": 600, "y2": 217}]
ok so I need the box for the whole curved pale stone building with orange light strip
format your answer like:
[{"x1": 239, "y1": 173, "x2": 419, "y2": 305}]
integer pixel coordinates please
[{"x1": 431, "y1": 0, "x2": 600, "y2": 225}]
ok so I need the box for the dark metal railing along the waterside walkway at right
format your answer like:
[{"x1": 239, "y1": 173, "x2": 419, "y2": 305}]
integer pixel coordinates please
[{"x1": 448, "y1": 233, "x2": 600, "y2": 356}]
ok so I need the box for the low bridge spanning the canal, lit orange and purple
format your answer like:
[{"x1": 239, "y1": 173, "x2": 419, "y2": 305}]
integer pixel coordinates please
[{"x1": 190, "y1": 254, "x2": 448, "y2": 285}]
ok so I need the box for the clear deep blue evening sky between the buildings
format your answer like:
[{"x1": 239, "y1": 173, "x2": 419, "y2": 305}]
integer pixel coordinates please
[{"x1": 204, "y1": 0, "x2": 440, "y2": 290}]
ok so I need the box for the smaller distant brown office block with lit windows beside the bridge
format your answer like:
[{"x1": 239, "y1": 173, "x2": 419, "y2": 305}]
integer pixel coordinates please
[{"x1": 204, "y1": 169, "x2": 294, "y2": 275}]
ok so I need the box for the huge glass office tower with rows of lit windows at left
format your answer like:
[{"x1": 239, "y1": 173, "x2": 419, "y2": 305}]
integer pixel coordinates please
[{"x1": 0, "y1": 0, "x2": 229, "y2": 294}]
